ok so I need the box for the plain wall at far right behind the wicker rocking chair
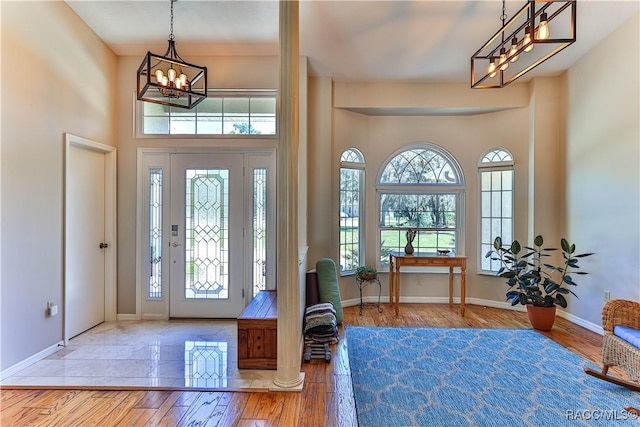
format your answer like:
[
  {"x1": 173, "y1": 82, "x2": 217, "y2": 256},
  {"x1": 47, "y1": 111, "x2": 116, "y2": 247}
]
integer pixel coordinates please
[{"x1": 566, "y1": 14, "x2": 640, "y2": 325}]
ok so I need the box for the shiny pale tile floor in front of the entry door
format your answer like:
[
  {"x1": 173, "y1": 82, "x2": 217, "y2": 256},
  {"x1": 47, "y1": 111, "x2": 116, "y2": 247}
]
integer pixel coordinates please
[{"x1": 0, "y1": 320, "x2": 275, "y2": 390}]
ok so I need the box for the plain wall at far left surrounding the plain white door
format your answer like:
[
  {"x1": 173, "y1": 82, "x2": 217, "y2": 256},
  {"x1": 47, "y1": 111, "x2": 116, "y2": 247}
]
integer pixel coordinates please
[{"x1": 0, "y1": 1, "x2": 116, "y2": 370}]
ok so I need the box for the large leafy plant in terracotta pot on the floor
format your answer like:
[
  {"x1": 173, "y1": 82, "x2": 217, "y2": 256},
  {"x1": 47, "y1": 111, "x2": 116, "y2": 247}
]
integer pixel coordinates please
[{"x1": 486, "y1": 235, "x2": 593, "y2": 331}]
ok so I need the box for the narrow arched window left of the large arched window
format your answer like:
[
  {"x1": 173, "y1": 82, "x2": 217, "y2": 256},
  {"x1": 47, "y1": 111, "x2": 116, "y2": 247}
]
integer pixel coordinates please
[{"x1": 339, "y1": 148, "x2": 365, "y2": 273}]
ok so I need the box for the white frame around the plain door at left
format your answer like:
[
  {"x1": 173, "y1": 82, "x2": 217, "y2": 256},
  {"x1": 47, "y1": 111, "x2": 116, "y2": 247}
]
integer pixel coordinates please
[{"x1": 62, "y1": 133, "x2": 118, "y2": 345}]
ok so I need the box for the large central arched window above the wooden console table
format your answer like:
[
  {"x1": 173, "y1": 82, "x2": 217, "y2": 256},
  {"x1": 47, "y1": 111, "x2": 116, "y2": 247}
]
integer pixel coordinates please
[{"x1": 378, "y1": 144, "x2": 464, "y2": 264}]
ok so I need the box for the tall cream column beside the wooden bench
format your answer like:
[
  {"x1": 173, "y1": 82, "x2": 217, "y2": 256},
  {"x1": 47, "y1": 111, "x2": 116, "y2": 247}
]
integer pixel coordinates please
[{"x1": 273, "y1": 0, "x2": 304, "y2": 388}]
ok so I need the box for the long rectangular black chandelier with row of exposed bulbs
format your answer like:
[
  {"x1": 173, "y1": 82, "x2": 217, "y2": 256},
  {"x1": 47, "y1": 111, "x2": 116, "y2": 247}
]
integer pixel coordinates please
[{"x1": 471, "y1": 0, "x2": 577, "y2": 89}]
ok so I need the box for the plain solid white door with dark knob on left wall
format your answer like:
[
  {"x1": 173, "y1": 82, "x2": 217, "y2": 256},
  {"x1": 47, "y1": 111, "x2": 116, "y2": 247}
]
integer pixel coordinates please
[{"x1": 65, "y1": 145, "x2": 109, "y2": 338}]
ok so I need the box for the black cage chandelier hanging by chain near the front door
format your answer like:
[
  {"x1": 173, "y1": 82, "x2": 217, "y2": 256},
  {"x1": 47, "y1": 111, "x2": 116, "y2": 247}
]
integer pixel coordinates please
[{"x1": 136, "y1": 0, "x2": 207, "y2": 109}]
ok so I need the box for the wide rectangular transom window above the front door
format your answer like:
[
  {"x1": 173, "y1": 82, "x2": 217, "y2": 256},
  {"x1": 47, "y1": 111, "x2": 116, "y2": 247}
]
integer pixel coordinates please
[{"x1": 139, "y1": 91, "x2": 276, "y2": 135}]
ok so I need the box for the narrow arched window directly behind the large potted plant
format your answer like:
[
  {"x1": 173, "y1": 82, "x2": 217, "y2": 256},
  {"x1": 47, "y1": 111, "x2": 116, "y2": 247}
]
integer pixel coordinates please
[{"x1": 478, "y1": 148, "x2": 514, "y2": 272}]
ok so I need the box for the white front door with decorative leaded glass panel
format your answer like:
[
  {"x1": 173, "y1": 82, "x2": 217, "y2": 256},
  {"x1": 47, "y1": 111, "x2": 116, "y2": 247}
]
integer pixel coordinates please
[{"x1": 169, "y1": 154, "x2": 244, "y2": 318}]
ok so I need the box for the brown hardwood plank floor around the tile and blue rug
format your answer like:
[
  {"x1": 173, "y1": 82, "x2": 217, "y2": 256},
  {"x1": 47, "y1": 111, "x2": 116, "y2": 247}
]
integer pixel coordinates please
[{"x1": 0, "y1": 304, "x2": 608, "y2": 427}]
